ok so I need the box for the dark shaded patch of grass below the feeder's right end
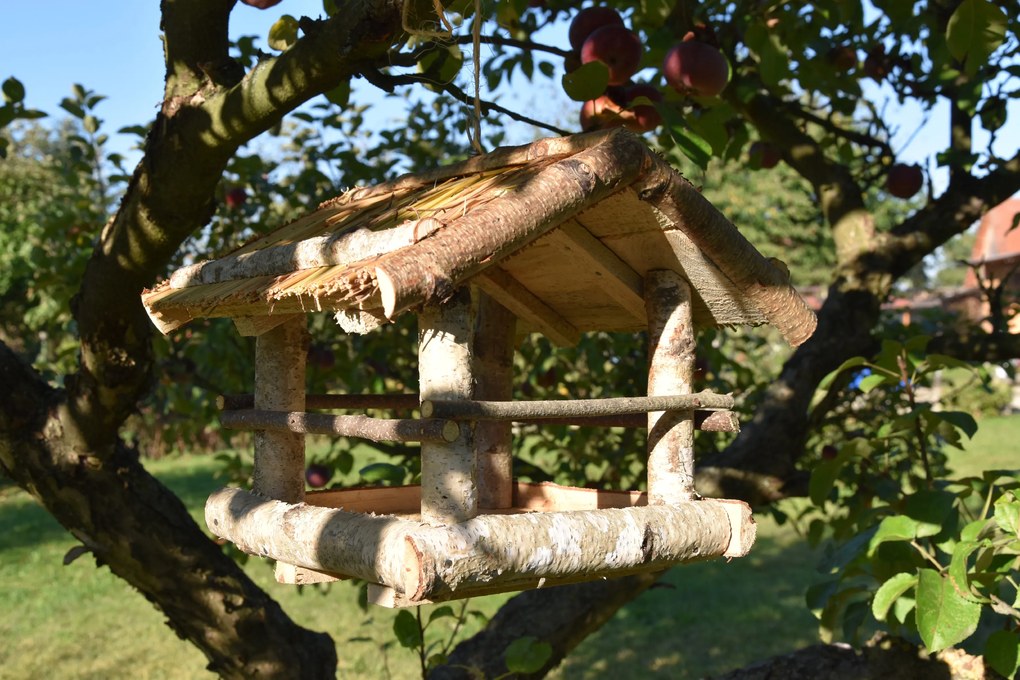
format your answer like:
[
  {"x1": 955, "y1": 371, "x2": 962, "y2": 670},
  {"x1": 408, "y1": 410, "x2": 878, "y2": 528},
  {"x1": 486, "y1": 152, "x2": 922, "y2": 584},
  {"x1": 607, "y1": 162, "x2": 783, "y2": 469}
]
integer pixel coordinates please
[{"x1": 553, "y1": 517, "x2": 818, "y2": 679}]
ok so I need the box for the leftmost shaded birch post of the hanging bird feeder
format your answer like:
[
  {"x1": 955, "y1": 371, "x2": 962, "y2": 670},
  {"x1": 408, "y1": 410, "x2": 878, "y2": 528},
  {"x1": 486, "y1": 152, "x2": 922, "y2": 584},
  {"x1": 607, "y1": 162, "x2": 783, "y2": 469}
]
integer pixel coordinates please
[{"x1": 252, "y1": 314, "x2": 308, "y2": 503}]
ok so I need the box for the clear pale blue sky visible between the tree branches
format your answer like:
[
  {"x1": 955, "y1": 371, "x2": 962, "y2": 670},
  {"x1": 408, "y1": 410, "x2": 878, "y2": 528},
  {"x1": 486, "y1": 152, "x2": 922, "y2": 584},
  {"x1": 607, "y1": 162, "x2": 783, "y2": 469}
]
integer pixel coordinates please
[{"x1": 0, "y1": 0, "x2": 1020, "y2": 195}]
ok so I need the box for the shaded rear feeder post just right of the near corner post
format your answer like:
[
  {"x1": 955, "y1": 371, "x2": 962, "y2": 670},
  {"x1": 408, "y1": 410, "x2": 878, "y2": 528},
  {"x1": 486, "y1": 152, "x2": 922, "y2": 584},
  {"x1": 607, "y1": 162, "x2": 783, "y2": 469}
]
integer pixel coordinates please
[{"x1": 473, "y1": 291, "x2": 517, "y2": 509}]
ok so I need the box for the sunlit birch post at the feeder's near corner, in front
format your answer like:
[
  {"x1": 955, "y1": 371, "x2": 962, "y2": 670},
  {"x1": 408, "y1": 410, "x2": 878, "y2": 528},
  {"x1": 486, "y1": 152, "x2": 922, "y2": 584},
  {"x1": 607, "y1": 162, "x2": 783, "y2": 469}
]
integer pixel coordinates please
[{"x1": 418, "y1": 286, "x2": 478, "y2": 525}]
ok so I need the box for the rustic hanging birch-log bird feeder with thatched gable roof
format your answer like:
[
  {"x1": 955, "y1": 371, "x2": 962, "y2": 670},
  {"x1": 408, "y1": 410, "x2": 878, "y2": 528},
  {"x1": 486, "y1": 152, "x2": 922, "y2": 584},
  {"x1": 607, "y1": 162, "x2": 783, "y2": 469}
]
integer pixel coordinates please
[{"x1": 143, "y1": 129, "x2": 815, "y2": 607}]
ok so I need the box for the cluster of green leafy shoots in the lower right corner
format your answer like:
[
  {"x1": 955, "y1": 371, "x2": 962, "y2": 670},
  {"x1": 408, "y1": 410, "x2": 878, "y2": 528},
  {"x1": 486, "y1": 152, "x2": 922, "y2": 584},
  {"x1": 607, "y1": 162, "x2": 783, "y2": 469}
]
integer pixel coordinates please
[{"x1": 800, "y1": 336, "x2": 1020, "y2": 677}]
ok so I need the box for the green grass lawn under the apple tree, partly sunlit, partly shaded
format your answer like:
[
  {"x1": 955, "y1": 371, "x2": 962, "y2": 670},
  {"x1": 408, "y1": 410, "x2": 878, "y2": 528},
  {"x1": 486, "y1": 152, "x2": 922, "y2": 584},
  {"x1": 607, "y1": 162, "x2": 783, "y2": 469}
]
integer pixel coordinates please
[{"x1": 0, "y1": 417, "x2": 1020, "y2": 679}]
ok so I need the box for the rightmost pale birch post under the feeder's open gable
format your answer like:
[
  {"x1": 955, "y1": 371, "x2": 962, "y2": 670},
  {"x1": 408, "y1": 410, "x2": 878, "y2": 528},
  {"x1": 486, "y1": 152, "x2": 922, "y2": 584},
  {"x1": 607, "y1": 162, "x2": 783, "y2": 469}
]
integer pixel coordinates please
[{"x1": 645, "y1": 270, "x2": 697, "y2": 505}]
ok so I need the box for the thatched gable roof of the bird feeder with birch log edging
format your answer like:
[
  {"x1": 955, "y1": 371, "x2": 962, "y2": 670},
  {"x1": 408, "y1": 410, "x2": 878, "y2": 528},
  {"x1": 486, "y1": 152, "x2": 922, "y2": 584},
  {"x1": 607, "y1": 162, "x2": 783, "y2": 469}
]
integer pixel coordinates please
[{"x1": 143, "y1": 129, "x2": 815, "y2": 345}]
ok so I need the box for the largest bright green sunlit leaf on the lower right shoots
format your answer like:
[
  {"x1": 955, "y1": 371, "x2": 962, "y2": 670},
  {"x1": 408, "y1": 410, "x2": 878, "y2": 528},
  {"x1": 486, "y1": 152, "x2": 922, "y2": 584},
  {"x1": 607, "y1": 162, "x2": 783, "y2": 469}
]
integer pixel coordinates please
[{"x1": 917, "y1": 569, "x2": 981, "y2": 653}]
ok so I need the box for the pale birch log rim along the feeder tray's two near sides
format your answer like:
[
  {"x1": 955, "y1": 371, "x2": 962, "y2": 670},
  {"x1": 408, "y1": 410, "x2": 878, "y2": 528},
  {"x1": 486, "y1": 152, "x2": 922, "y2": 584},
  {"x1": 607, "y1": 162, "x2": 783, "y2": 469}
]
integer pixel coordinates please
[{"x1": 205, "y1": 489, "x2": 755, "y2": 605}]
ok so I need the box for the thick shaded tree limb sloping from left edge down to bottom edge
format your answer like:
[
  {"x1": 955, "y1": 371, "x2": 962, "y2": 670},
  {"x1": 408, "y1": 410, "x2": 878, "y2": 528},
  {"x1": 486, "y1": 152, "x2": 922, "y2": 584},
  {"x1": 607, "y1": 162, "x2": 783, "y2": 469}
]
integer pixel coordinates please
[{"x1": 0, "y1": 345, "x2": 337, "y2": 678}]
